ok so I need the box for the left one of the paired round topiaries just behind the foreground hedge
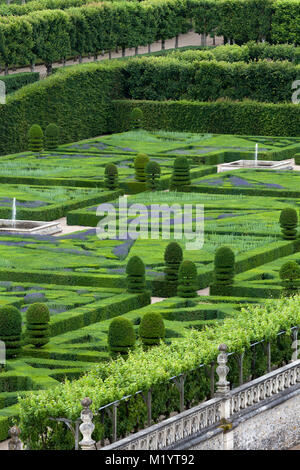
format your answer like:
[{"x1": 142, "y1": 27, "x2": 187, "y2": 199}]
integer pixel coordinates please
[{"x1": 108, "y1": 317, "x2": 135, "y2": 354}]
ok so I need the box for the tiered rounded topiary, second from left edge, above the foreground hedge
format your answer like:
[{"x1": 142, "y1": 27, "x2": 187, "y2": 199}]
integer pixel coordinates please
[{"x1": 26, "y1": 302, "x2": 50, "y2": 348}]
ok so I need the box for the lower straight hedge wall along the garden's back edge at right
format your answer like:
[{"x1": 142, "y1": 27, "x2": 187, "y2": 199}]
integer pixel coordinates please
[{"x1": 111, "y1": 100, "x2": 300, "y2": 136}]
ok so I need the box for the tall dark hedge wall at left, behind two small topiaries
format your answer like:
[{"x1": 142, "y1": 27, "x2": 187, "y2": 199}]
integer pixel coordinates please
[{"x1": 0, "y1": 64, "x2": 122, "y2": 154}]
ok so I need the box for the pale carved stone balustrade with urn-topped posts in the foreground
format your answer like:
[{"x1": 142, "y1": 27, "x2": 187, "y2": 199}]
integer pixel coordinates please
[{"x1": 9, "y1": 334, "x2": 300, "y2": 450}]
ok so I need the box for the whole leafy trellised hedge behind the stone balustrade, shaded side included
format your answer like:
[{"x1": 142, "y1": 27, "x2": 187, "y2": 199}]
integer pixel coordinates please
[{"x1": 19, "y1": 296, "x2": 300, "y2": 449}]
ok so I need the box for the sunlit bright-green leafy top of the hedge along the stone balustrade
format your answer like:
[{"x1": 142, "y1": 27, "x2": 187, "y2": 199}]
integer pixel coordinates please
[{"x1": 19, "y1": 295, "x2": 300, "y2": 439}]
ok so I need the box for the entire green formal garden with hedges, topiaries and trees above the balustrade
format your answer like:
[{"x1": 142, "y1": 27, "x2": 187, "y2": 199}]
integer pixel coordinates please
[{"x1": 0, "y1": 0, "x2": 300, "y2": 450}]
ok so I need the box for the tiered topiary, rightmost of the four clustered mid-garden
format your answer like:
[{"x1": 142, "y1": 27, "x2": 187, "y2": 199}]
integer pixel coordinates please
[{"x1": 214, "y1": 246, "x2": 235, "y2": 286}]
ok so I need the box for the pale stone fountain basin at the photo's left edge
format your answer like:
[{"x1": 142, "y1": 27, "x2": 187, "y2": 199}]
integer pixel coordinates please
[{"x1": 0, "y1": 219, "x2": 62, "y2": 235}]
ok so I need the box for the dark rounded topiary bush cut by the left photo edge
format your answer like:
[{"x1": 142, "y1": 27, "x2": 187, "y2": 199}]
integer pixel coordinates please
[{"x1": 0, "y1": 305, "x2": 22, "y2": 359}]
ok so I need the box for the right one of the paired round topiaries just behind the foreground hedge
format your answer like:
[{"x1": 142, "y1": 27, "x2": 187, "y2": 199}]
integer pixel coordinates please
[{"x1": 139, "y1": 312, "x2": 166, "y2": 346}]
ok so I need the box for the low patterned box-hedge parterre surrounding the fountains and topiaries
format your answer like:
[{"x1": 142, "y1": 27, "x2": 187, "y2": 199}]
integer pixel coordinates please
[{"x1": 0, "y1": 129, "x2": 300, "y2": 448}]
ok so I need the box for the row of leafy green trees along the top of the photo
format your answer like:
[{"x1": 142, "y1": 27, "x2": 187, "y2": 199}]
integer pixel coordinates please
[{"x1": 0, "y1": 0, "x2": 300, "y2": 73}]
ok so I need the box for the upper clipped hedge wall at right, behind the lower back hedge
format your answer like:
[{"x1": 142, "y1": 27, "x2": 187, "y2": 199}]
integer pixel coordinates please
[{"x1": 124, "y1": 57, "x2": 300, "y2": 103}]
